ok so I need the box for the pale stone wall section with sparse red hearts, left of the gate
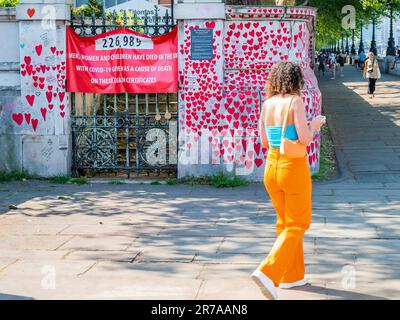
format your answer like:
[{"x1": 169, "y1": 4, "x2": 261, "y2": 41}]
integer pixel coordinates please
[{"x1": 0, "y1": 0, "x2": 71, "y2": 177}]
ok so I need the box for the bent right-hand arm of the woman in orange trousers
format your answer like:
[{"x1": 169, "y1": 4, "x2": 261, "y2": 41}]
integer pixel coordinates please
[{"x1": 292, "y1": 97, "x2": 323, "y2": 146}]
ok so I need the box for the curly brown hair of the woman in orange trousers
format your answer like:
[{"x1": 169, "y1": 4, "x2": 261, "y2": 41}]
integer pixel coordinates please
[{"x1": 267, "y1": 61, "x2": 304, "y2": 99}]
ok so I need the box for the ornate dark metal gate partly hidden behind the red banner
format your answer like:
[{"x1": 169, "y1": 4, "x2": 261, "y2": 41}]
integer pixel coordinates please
[{"x1": 71, "y1": 6, "x2": 178, "y2": 177}]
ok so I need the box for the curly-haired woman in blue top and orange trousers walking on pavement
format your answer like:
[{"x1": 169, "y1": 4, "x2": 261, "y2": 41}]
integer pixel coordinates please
[{"x1": 252, "y1": 62, "x2": 325, "y2": 299}]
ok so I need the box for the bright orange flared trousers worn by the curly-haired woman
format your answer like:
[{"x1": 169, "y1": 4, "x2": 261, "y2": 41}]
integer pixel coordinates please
[{"x1": 260, "y1": 148, "x2": 312, "y2": 286}]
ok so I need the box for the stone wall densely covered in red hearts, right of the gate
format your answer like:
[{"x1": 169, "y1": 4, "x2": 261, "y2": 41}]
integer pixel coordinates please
[{"x1": 176, "y1": 4, "x2": 322, "y2": 181}]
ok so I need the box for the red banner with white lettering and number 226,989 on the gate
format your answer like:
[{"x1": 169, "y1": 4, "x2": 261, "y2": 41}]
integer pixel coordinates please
[{"x1": 67, "y1": 27, "x2": 178, "y2": 93}]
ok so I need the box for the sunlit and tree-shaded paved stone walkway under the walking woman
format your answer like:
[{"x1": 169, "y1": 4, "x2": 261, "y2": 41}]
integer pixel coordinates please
[{"x1": 0, "y1": 67, "x2": 400, "y2": 300}]
